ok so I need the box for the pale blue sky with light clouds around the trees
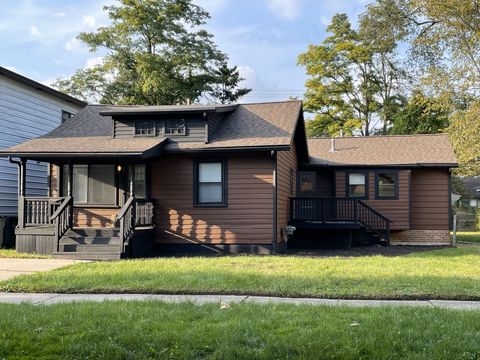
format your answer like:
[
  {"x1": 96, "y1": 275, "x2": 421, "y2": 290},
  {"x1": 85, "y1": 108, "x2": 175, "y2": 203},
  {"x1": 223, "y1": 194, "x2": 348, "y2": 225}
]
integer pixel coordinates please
[{"x1": 0, "y1": 0, "x2": 369, "y2": 102}]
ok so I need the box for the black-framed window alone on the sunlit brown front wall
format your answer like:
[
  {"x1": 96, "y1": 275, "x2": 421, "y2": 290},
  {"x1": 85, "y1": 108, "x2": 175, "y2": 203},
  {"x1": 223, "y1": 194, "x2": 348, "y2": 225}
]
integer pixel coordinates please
[{"x1": 195, "y1": 161, "x2": 227, "y2": 206}]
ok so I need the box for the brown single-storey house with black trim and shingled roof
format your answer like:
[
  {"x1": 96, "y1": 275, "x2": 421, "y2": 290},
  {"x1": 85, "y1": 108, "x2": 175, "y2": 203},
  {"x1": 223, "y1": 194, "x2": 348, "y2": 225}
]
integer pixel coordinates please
[{"x1": 0, "y1": 101, "x2": 456, "y2": 259}]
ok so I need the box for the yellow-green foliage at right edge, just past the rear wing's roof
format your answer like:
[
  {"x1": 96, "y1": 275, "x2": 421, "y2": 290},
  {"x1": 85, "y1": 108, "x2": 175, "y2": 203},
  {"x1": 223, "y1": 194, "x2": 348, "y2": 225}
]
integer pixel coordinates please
[{"x1": 448, "y1": 100, "x2": 480, "y2": 175}]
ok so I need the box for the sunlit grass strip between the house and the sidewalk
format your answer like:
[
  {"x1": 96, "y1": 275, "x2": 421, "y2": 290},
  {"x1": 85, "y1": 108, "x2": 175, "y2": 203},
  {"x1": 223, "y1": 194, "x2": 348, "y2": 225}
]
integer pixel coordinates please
[{"x1": 0, "y1": 246, "x2": 480, "y2": 299}]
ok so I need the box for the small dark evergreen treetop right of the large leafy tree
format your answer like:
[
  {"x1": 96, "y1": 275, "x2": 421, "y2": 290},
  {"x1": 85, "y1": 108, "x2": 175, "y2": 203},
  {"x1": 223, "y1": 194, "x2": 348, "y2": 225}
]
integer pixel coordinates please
[{"x1": 206, "y1": 64, "x2": 252, "y2": 104}]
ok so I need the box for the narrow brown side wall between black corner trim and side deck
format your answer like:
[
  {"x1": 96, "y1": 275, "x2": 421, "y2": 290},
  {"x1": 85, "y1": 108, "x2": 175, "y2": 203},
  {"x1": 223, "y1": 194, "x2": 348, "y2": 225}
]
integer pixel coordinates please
[{"x1": 277, "y1": 142, "x2": 298, "y2": 242}]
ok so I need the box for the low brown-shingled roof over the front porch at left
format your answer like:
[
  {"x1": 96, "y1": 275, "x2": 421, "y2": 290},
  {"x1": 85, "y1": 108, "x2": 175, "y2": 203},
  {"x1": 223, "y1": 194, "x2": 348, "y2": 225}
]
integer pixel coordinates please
[{"x1": 0, "y1": 136, "x2": 166, "y2": 159}]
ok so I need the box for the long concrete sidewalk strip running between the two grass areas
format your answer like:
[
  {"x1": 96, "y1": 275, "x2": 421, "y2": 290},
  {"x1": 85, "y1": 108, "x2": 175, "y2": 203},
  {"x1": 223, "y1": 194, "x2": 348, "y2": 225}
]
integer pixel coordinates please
[{"x1": 0, "y1": 293, "x2": 480, "y2": 310}]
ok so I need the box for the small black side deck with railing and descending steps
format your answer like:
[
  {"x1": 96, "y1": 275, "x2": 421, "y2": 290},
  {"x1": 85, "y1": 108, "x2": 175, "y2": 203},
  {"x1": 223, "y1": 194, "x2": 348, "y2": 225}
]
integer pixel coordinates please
[{"x1": 289, "y1": 197, "x2": 391, "y2": 245}]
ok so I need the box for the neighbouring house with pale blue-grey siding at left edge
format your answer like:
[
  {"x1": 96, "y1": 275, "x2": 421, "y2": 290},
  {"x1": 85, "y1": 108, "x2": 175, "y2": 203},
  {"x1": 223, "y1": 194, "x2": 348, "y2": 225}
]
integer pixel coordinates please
[{"x1": 0, "y1": 67, "x2": 86, "y2": 246}]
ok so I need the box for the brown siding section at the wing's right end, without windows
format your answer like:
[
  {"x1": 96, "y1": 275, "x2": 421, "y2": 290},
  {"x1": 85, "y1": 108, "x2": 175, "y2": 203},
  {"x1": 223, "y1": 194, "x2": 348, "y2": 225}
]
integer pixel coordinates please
[{"x1": 412, "y1": 169, "x2": 450, "y2": 230}]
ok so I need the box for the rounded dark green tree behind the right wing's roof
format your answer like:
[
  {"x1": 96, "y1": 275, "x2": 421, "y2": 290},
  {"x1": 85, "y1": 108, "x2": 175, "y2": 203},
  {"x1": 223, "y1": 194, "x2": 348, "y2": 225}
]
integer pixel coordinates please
[{"x1": 390, "y1": 90, "x2": 449, "y2": 134}]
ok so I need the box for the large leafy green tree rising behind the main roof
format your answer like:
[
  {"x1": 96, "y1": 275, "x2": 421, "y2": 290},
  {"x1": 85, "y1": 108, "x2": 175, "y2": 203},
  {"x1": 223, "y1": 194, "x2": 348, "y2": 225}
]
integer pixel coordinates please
[{"x1": 55, "y1": 0, "x2": 249, "y2": 105}]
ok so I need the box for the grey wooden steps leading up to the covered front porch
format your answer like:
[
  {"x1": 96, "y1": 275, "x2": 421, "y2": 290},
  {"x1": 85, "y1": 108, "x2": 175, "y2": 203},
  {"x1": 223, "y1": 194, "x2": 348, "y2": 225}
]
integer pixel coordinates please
[{"x1": 53, "y1": 228, "x2": 124, "y2": 260}]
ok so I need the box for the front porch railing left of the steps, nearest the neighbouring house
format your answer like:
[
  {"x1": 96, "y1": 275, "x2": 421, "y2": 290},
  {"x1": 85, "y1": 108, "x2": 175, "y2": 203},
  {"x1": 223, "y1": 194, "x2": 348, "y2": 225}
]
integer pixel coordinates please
[{"x1": 18, "y1": 196, "x2": 65, "y2": 228}]
